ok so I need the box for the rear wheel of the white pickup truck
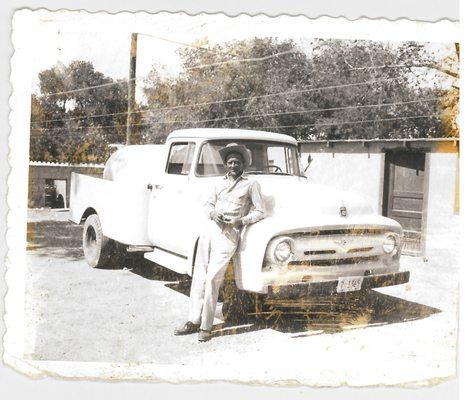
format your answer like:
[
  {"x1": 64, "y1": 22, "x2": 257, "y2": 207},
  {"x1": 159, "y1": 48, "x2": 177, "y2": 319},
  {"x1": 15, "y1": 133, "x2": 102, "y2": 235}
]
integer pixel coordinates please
[{"x1": 82, "y1": 214, "x2": 115, "y2": 268}]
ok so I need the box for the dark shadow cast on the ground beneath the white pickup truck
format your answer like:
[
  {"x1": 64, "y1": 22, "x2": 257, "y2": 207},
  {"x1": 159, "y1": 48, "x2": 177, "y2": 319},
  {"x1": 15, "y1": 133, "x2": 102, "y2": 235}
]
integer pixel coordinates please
[{"x1": 128, "y1": 263, "x2": 440, "y2": 337}]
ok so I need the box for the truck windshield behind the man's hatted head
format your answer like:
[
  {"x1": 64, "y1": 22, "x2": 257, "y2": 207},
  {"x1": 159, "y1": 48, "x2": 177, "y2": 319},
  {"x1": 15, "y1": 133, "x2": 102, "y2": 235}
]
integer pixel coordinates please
[{"x1": 196, "y1": 139, "x2": 301, "y2": 176}]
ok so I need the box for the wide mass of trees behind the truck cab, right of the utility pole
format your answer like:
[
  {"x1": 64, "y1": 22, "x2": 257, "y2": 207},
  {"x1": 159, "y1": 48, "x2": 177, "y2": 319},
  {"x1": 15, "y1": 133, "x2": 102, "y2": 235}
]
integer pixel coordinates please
[{"x1": 144, "y1": 38, "x2": 454, "y2": 142}]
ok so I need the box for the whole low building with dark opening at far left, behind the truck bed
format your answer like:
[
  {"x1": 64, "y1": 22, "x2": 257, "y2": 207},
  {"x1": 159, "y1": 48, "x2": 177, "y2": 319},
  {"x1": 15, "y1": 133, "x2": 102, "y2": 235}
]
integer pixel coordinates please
[{"x1": 28, "y1": 161, "x2": 104, "y2": 208}]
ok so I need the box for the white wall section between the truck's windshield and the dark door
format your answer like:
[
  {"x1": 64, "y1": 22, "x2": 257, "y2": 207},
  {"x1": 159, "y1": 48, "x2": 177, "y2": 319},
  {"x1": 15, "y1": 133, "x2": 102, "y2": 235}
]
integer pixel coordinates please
[{"x1": 302, "y1": 152, "x2": 384, "y2": 213}]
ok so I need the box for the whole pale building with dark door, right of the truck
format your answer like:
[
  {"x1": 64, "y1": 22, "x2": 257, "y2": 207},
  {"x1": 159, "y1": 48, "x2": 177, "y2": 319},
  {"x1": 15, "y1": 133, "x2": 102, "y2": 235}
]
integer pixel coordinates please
[{"x1": 300, "y1": 138, "x2": 459, "y2": 256}]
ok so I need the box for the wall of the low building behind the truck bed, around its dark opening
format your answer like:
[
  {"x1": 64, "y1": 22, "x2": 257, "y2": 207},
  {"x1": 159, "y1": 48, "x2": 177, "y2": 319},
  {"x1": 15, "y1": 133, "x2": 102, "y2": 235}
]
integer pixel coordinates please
[{"x1": 28, "y1": 162, "x2": 103, "y2": 208}]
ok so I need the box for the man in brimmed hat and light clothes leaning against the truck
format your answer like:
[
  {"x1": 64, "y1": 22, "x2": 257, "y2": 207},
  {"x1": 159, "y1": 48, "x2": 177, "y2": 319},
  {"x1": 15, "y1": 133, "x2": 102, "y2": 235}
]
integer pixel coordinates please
[{"x1": 174, "y1": 143, "x2": 264, "y2": 342}]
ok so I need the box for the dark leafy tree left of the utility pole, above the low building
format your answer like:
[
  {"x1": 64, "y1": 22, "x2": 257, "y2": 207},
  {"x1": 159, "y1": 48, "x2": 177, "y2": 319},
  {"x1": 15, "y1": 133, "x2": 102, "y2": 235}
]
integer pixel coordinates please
[{"x1": 30, "y1": 61, "x2": 140, "y2": 162}]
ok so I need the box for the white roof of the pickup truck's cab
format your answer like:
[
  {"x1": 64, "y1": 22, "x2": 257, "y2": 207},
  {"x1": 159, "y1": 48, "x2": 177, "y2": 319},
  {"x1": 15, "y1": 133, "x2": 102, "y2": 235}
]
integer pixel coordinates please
[{"x1": 168, "y1": 128, "x2": 297, "y2": 144}]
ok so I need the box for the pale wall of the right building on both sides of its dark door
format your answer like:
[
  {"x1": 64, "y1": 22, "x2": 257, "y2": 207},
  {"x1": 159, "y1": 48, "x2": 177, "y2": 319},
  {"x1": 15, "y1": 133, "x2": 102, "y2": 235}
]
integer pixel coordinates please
[{"x1": 301, "y1": 141, "x2": 459, "y2": 258}]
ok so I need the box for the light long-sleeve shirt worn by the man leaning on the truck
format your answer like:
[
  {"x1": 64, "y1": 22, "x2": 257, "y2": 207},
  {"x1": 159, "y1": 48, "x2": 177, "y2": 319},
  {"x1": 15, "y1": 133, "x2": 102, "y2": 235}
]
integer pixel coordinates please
[{"x1": 205, "y1": 175, "x2": 265, "y2": 225}]
